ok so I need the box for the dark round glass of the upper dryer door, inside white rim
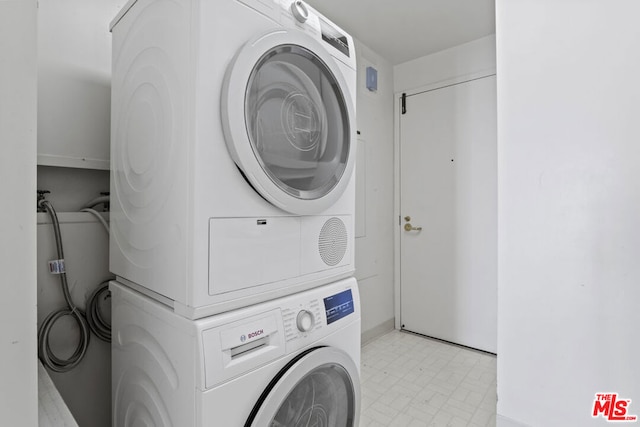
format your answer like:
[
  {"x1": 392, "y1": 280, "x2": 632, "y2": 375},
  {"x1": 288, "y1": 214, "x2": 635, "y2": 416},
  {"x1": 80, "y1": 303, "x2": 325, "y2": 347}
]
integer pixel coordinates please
[{"x1": 245, "y1": 45, "x2": 350, "y2": 199}]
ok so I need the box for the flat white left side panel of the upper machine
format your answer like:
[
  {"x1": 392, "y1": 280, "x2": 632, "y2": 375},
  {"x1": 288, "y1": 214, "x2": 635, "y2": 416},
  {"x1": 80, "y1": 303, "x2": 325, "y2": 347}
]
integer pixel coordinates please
[{"x1": 109, "y1": 0, "x2": 190, "y2": 300}]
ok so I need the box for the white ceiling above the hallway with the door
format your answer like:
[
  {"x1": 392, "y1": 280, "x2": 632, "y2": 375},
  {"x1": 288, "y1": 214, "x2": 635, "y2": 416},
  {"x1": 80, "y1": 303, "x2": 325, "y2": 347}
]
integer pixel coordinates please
[{"x1": 306, "y1": 0, "x2": 495, "y2": 65}]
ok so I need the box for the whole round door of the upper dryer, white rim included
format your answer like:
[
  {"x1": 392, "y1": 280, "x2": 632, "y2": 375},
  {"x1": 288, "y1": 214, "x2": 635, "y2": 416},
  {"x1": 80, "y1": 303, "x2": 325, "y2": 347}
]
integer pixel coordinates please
[{"x1": 221, "y1": 30, "x2": 356, "y2": 214}]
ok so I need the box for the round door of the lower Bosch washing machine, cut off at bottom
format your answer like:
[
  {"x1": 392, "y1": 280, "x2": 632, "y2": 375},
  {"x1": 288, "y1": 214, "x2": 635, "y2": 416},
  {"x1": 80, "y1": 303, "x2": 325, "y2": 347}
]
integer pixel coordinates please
[{"x1": 245, "y1": 347, "x2": 360, "y2": 427}]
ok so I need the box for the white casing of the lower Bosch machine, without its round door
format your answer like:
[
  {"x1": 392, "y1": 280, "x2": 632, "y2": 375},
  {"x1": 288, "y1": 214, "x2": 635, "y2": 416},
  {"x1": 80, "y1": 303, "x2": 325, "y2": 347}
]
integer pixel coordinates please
[{"x1": 110, "y1": 278, "x2": 361, "y2": 427}]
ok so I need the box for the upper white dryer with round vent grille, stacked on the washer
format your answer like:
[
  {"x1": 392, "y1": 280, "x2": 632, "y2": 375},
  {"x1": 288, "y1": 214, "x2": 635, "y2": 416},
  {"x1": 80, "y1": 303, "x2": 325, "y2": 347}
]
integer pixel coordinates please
[{"x1": 110, "y1": 0, "x2": 356, "y2": 319}]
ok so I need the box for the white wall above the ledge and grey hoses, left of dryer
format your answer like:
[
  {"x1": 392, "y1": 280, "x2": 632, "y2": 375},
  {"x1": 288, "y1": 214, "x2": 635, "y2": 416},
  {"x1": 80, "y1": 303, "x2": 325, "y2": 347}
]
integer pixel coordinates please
[{"x1": 38, "y1": 0, "x2": 125, "y2": 170}]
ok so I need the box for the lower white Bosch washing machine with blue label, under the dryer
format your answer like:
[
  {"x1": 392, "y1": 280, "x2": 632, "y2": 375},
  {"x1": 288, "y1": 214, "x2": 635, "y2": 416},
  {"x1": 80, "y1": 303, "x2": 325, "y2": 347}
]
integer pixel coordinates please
[{"x1": 111, "y1": 278, "x2": 360, "y2": 427}]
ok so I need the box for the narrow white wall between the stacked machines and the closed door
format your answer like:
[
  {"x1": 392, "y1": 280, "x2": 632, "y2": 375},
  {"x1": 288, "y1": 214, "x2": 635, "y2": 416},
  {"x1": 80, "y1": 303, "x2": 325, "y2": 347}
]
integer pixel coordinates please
[{"x1": 356, "y1": 43, "x2": 394, "y2": 341}]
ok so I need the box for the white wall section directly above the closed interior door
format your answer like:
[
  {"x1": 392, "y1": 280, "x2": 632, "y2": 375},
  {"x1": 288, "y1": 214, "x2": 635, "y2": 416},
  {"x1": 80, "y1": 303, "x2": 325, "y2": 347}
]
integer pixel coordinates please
[{"x1": 393, "y1": 35, "x2": 496, "y2": 93}]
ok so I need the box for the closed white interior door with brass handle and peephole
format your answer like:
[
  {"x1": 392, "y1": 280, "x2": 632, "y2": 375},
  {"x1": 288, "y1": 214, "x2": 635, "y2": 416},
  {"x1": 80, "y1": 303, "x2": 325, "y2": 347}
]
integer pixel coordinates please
[{"x1": 400, "y1": 76, "x2": 497, "y2": 353}]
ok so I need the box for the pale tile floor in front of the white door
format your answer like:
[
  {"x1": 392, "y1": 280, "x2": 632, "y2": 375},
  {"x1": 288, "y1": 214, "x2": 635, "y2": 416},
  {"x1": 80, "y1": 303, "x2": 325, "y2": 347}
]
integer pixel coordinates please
[{"x1": 360, "y1": 331, "x2": 496, "y2": 427}]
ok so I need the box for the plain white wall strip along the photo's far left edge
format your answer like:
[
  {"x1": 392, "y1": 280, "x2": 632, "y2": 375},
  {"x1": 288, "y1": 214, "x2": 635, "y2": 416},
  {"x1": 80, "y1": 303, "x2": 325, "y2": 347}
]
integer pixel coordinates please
[{"x1": 0, "y1": 0, "x2": 38, "y2": 426}]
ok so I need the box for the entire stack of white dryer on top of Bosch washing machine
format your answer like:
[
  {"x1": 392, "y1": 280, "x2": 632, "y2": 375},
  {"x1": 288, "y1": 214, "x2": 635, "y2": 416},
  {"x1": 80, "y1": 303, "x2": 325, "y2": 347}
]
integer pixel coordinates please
[{"x1": 110, "y1": 0, "x2": 360, "y2": 426}]
